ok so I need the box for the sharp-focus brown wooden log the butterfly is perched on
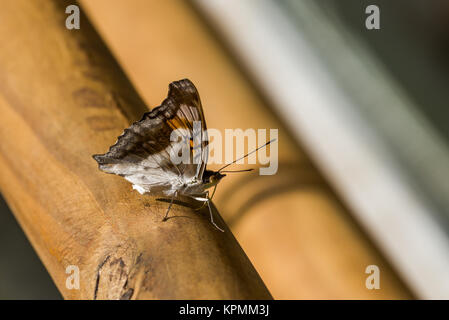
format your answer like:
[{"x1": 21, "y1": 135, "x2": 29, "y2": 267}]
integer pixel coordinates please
[{"x1": 0, "y1": 0, "x2": 271, "y2": 299}]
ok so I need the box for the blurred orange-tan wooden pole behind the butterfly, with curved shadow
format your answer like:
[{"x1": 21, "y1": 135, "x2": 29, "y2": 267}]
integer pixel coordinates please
[{"x1": 81, "y1": 0, "x2": 413, "y2": 299}]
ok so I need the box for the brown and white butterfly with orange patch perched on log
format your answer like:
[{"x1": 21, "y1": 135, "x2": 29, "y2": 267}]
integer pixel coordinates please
[{"x1": 93, "y1": 79, "x2": 271, "y2": 231}]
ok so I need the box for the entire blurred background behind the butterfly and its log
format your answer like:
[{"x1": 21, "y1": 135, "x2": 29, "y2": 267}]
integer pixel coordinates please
[{"x1": 0, "y1": 0, "x2": 449, "y2": 299}]
